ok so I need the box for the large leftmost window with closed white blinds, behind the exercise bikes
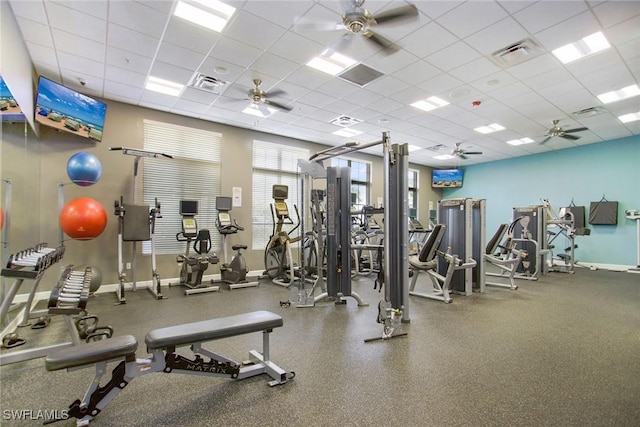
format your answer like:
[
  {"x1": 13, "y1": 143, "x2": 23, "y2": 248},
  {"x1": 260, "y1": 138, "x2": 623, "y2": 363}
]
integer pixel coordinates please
[{"x1": 141, "y1": 120, "x2": 222, "y2": 255}]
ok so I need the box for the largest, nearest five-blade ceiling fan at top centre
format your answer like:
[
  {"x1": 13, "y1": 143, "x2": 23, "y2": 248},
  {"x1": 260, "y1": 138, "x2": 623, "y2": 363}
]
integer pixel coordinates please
[{"x1": 295, "y1": 0, "x2": 418, "y2": 54}]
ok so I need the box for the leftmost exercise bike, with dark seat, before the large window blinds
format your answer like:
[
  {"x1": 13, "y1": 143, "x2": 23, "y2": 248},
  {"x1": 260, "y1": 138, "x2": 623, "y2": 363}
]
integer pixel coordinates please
[{"x1": 176, "y1": 200, "x2": 220, "y2": 295}]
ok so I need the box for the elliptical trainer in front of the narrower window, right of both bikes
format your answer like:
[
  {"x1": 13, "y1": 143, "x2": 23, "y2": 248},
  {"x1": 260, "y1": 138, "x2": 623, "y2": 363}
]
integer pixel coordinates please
[{"x1": 264, "y1": 184, "x2": 301, "y2": 287}]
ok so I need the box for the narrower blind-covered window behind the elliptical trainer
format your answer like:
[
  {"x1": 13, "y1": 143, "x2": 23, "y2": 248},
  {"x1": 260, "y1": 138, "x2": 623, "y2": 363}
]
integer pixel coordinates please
[{"x1": 251, "y1": 140, "x2": 309, "y2": 250}]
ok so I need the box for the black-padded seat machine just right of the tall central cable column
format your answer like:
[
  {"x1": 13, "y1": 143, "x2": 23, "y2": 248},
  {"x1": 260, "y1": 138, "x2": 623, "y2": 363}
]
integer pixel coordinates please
[{"x1": 409, "y1": 224, "x2": 477, "y2": 303}]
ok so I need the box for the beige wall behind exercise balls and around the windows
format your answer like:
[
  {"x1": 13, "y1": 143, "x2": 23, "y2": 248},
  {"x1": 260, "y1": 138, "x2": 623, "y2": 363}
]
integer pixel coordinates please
[{"x1": 1, "y1": 101, "x2": 440, "y2": 290}]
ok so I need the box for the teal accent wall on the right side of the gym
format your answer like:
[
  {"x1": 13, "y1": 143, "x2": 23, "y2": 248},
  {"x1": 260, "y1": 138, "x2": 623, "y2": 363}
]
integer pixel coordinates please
[{"x1": 442, "y1": 136, "x2": 640, "y2": 266}]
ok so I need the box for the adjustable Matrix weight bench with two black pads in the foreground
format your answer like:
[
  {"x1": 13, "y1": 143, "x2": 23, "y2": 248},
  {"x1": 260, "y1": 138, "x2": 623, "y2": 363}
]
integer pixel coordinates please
[{"x1": 45, "y1": 311, "x2": 295, "y2": 426}]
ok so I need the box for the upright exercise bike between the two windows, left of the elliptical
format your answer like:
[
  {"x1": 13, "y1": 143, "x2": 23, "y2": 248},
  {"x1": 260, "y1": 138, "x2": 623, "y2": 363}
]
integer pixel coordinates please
[{"x1": 216, "y1": 196, "x2": 260, "y2": 289}]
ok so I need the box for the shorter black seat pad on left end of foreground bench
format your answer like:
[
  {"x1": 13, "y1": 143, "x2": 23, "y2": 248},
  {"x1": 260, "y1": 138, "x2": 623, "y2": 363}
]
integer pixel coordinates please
[{"x1": 44, "y1": 335, "x2": 138, "y2": 371}]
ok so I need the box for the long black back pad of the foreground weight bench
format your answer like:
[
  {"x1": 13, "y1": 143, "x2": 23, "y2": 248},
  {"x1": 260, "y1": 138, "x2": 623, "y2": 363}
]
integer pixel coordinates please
[{"x1": 145, "y1": 311, "x2": 283, "y2": 350}]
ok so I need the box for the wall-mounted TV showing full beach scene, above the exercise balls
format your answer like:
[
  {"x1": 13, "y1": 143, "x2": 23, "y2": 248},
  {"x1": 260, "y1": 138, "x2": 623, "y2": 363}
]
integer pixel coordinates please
[{"x1": 36, "y1": 76, "x2": 107, "y2": 142}]
